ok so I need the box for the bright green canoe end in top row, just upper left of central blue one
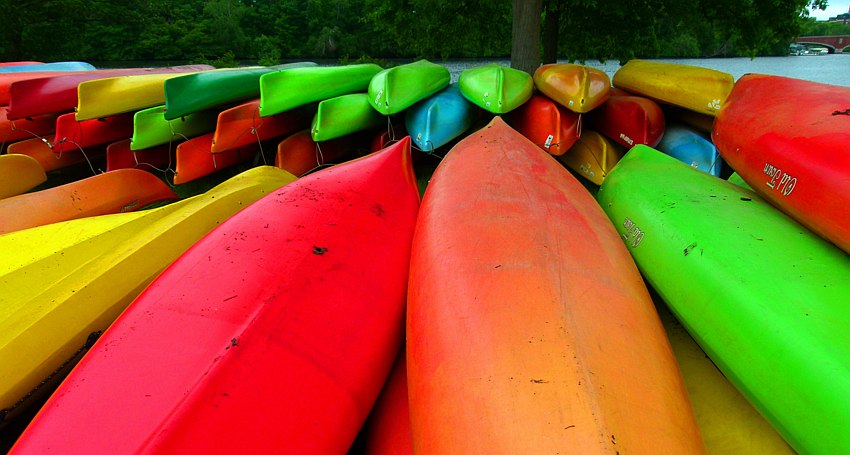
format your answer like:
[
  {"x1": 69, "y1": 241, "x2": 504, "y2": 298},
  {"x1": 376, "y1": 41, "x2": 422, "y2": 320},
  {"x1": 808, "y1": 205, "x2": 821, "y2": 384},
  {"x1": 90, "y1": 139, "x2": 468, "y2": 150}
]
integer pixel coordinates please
[{"x1": 369, "y1": 60, "x2": 451, "y2": 115}]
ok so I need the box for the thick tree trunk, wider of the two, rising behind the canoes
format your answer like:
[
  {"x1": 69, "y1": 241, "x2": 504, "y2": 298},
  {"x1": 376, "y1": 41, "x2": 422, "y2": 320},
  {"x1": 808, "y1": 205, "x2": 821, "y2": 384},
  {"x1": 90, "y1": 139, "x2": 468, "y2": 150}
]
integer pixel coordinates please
[{"x1": 511, "y1": 0, "x2": 543, "y2": 74}]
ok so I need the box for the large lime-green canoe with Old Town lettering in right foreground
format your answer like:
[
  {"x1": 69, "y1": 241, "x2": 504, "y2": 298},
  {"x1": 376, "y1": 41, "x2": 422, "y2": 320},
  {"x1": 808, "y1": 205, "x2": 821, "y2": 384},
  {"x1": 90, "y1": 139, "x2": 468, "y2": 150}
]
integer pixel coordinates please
[{"x1": 597, "y1": 145, "x2": 850, "y2": 454}]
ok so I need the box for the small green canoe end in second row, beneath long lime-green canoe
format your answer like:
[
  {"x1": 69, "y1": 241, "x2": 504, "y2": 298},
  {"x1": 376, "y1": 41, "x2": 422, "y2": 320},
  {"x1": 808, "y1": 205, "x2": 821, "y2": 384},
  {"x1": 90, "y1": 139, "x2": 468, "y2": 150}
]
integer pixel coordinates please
[{"x1": 310, "y1": 93, "x2": 387, "y2": 142}]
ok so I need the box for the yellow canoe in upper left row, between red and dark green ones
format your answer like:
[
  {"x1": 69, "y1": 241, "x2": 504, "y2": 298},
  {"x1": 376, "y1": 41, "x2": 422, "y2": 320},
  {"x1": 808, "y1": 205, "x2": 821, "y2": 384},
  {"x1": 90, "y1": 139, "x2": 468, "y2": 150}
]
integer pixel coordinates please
[{"x1": 75, "y1": 72, "x2": 204, "y2": 122}]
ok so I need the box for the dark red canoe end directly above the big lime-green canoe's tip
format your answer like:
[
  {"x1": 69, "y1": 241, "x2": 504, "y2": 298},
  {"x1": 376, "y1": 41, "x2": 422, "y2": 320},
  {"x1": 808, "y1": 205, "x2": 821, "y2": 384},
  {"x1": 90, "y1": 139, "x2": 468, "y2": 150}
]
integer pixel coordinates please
[{"x1": 587, "y1": 96, "x2": 665, "y2": 149}]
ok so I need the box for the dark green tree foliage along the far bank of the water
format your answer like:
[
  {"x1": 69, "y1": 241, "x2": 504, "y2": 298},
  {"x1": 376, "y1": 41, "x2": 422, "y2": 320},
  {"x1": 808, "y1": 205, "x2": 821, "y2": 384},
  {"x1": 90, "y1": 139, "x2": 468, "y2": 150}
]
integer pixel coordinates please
[{"x1": 0, "y1": 0, "x2": 836, "y2": 66}]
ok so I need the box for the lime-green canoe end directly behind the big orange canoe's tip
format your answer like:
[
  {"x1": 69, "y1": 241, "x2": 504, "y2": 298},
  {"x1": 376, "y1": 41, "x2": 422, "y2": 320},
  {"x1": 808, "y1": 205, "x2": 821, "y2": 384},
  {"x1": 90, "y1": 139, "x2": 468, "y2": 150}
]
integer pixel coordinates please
[{"x1": 458, "y1": 63, "x2": 534, "y2": 114}]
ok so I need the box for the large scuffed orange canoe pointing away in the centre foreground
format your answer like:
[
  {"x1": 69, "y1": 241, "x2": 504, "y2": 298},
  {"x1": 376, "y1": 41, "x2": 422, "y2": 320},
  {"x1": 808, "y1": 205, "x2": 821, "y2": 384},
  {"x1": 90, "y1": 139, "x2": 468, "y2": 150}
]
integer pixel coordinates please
[{"x1": 407, "y1": 117, "x2": 704, "y2": 454}]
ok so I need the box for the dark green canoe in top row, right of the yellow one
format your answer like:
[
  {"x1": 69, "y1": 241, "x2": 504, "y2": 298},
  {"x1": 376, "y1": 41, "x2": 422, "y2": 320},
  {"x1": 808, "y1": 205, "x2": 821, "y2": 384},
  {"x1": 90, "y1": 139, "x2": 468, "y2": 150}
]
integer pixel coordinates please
[{"x1": 164, "y1": 62, "x2": 316, "y2": 120}]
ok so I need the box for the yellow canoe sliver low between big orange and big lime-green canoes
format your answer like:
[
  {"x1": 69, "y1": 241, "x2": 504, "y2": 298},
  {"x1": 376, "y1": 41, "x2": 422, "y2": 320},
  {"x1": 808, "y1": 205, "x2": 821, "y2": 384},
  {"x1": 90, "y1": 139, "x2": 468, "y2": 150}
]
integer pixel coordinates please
[{"x1": 656, "y1": 301, "x2": 796, "y2": 455}]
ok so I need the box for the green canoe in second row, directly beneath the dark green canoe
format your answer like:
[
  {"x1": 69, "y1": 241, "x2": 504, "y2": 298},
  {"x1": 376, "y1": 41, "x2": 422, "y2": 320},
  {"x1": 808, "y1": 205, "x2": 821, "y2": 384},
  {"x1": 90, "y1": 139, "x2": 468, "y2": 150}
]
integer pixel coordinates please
[{"x1": 130, "y1": 106, "x2": 218, "y2": 150}]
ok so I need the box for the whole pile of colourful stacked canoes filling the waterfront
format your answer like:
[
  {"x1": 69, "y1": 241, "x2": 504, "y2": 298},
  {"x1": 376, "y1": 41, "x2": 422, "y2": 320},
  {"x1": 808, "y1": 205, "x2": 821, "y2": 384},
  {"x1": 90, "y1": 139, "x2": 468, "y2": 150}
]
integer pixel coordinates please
[{"x1": 0, "y1": 60, "x2": 850, "y2": 453}]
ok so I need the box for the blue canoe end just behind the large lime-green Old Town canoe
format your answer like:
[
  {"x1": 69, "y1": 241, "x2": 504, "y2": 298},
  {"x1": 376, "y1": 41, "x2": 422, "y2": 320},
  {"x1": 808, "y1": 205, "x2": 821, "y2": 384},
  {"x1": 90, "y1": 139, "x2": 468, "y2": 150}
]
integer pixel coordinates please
[{"x1": 657, "y1": 123, "x2": 723, "y2": 176}]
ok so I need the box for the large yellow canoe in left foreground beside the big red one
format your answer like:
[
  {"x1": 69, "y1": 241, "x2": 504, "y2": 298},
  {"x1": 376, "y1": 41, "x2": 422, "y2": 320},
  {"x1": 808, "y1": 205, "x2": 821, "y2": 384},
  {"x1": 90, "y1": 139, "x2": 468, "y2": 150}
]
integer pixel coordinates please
[{"x1": 0, "y1": 166, "x2": 295, "y2": 425}]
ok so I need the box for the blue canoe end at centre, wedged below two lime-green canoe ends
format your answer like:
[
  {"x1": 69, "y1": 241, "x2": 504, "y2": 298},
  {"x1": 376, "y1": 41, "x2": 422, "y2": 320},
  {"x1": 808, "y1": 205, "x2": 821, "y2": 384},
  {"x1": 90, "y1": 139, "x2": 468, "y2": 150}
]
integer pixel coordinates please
[{"x1": 404, "y1": 84, "x2": 475, "y2": 152}]
